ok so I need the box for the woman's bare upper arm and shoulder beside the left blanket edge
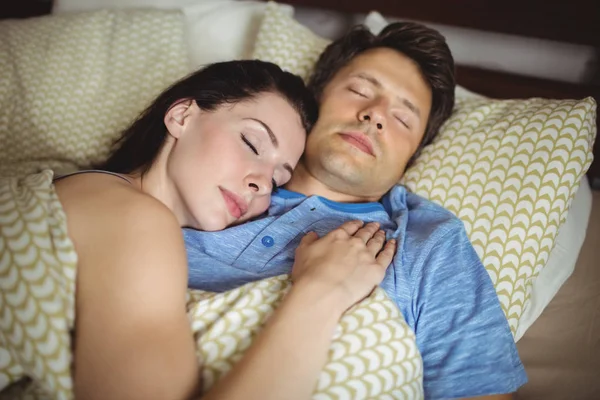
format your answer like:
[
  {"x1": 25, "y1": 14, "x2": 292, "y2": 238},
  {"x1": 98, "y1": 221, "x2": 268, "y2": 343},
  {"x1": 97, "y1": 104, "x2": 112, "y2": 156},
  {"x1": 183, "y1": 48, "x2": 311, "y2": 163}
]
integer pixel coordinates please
[{"x1": 57, "y1": 180, "x2": 200, "y2": 400}]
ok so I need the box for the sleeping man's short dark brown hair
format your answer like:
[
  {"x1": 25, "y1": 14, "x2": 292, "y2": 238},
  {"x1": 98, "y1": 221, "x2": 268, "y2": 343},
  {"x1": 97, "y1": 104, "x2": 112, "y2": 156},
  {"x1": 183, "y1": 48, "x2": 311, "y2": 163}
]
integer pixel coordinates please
[{"x1": 308, "y1": 22, "x2": 456, "y2": 165}]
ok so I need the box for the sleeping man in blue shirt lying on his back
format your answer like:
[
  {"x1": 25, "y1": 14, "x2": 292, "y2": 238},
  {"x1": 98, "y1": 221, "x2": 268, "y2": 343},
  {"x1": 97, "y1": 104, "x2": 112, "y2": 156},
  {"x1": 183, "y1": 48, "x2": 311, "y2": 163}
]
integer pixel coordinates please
[{"x1": 185, "y1": 23, "x2": 526, "y2": 398}]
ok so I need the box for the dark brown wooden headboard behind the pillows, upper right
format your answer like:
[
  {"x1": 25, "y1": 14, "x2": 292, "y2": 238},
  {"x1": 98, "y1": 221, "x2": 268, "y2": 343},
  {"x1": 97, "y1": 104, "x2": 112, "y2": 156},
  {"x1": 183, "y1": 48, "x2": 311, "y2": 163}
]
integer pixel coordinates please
[{"x1": 270, "y1": 0, "x2": 600, "y2": 182}]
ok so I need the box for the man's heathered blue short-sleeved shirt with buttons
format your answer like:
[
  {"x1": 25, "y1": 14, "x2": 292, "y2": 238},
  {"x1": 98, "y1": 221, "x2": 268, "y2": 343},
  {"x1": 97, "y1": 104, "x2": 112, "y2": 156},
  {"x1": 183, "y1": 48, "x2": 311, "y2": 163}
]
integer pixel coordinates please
[{"x1": 184, "y1": 186, "x2": 527, "y2": 399}]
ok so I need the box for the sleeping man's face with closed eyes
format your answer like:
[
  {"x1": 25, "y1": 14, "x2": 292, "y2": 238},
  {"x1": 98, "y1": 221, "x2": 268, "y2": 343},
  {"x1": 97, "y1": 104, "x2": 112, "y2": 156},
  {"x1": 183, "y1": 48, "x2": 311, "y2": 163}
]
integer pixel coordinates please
[{"x1": 303, "y1": 48, "x2": 431, "y2": 199}]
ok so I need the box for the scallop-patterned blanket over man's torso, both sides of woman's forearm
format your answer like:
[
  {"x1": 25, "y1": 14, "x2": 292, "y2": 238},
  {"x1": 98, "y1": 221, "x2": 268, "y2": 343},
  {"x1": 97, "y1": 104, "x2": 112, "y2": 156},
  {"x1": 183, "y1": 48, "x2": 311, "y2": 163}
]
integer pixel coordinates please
[{"x1": 188, "y1": 275, "x2": 424, "y2": 400}]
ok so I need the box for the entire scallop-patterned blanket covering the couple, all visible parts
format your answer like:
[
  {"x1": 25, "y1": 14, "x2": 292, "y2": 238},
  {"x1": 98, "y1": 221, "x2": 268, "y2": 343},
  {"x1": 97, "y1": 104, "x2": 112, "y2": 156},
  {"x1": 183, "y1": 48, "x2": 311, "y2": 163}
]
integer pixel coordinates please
[{"x1": 0, "y1": 170, "x2": 423, "y2": 400}]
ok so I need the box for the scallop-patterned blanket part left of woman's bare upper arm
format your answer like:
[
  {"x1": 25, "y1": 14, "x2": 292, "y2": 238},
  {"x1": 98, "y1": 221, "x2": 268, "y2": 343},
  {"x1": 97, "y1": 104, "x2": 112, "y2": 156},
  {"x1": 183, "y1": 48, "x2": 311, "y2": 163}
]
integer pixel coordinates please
[{"x1": 0, "y1": 170, "x2": 77, "y2": 399}]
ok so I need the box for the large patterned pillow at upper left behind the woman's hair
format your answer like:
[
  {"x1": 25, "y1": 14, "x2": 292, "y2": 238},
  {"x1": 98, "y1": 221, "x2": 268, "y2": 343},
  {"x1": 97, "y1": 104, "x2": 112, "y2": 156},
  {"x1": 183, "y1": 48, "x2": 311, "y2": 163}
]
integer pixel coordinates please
[{"x1": 0, "y1": 10, "x2": 188, "y2": 175}]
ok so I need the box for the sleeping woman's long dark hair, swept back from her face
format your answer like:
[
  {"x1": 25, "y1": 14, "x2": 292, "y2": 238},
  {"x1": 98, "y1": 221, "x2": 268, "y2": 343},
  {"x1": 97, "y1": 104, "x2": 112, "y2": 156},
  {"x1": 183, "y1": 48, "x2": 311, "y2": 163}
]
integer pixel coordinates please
[{"x1": 96, "y1": 60, "x2": 318, "y2": 174}]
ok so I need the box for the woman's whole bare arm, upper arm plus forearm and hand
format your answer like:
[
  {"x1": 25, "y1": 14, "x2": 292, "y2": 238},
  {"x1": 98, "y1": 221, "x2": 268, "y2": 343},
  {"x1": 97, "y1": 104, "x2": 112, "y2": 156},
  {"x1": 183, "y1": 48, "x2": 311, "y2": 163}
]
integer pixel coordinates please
[{"x1": 59, "y1": 175, "x2": 394, "y2": 400}]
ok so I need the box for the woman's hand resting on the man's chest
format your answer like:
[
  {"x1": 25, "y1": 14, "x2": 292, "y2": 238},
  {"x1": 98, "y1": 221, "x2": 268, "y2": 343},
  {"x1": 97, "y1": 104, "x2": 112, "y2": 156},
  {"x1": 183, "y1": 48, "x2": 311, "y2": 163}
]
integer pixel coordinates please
[{"x1": 292, "y1": 221, "x2": 396, "y2": 312}]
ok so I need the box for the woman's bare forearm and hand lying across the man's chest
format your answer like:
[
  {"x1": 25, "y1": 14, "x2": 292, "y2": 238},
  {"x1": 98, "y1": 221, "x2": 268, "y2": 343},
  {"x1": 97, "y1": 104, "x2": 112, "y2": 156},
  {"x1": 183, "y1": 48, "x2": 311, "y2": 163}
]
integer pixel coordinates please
[{"x1": 204, "y1": 221, "x2": 395, "y2": 400}]
